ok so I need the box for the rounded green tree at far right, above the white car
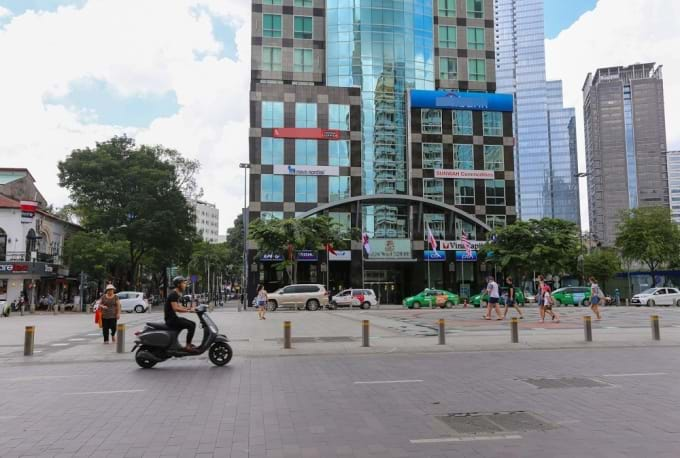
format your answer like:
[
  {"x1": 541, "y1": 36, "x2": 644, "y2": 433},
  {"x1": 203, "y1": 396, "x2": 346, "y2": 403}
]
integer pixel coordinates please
[{"x1": 616, "y1": 207, "x2": 680, "y2": 285}]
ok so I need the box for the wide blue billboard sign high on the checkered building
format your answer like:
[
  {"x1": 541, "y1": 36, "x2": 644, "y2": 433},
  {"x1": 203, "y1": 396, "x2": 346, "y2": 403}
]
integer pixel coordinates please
[{"x1": 410, "y1": 89, "x2": 513, "y2": 112}]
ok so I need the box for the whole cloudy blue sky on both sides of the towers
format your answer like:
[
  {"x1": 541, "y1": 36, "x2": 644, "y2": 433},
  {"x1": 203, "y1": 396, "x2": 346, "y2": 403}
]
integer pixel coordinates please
[{"x1": 0, "y1": 0, "x2": 680, "y2": 234}]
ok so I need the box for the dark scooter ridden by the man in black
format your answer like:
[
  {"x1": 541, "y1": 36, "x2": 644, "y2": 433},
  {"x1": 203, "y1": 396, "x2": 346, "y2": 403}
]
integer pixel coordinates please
[{"x1": 131, "y1": 305, "x2": 234, "y2": 369}]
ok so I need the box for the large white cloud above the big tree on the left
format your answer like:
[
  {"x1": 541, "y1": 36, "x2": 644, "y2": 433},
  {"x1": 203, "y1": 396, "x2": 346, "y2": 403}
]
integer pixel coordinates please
[{"x1": 0, "y1": 0, "x2": 250, "y2": 232}]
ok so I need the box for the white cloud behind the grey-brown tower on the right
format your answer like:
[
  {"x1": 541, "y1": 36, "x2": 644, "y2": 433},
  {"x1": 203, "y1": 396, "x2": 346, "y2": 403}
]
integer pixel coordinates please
[{"x1": 546, "y1": 0, "x2": 680, "y2": 229}]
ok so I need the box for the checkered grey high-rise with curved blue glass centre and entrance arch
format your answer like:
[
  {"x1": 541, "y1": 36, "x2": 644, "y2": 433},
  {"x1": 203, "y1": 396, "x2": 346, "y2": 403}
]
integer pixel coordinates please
[{"x1": 248, "y1": 0, "x2": 515, "y2": 302}]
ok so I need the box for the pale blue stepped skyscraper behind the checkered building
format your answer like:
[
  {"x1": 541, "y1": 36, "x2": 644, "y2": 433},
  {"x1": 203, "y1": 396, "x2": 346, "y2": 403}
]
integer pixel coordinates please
[{"x1": 494, "y1": 0, "x2": 581, "y2": 225}]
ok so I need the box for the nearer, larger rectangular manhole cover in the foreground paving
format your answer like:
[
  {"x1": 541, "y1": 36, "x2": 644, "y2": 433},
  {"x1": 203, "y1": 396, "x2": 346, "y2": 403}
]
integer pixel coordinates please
[{"x1": 436, "y1": 411, "x2": 556, "y2": 434}]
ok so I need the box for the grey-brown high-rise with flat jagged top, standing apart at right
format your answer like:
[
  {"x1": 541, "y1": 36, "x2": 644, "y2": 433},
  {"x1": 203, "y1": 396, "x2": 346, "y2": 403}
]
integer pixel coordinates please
[{"x1": 583, "y1": 63, "x2": 668, "y2": 245}]
